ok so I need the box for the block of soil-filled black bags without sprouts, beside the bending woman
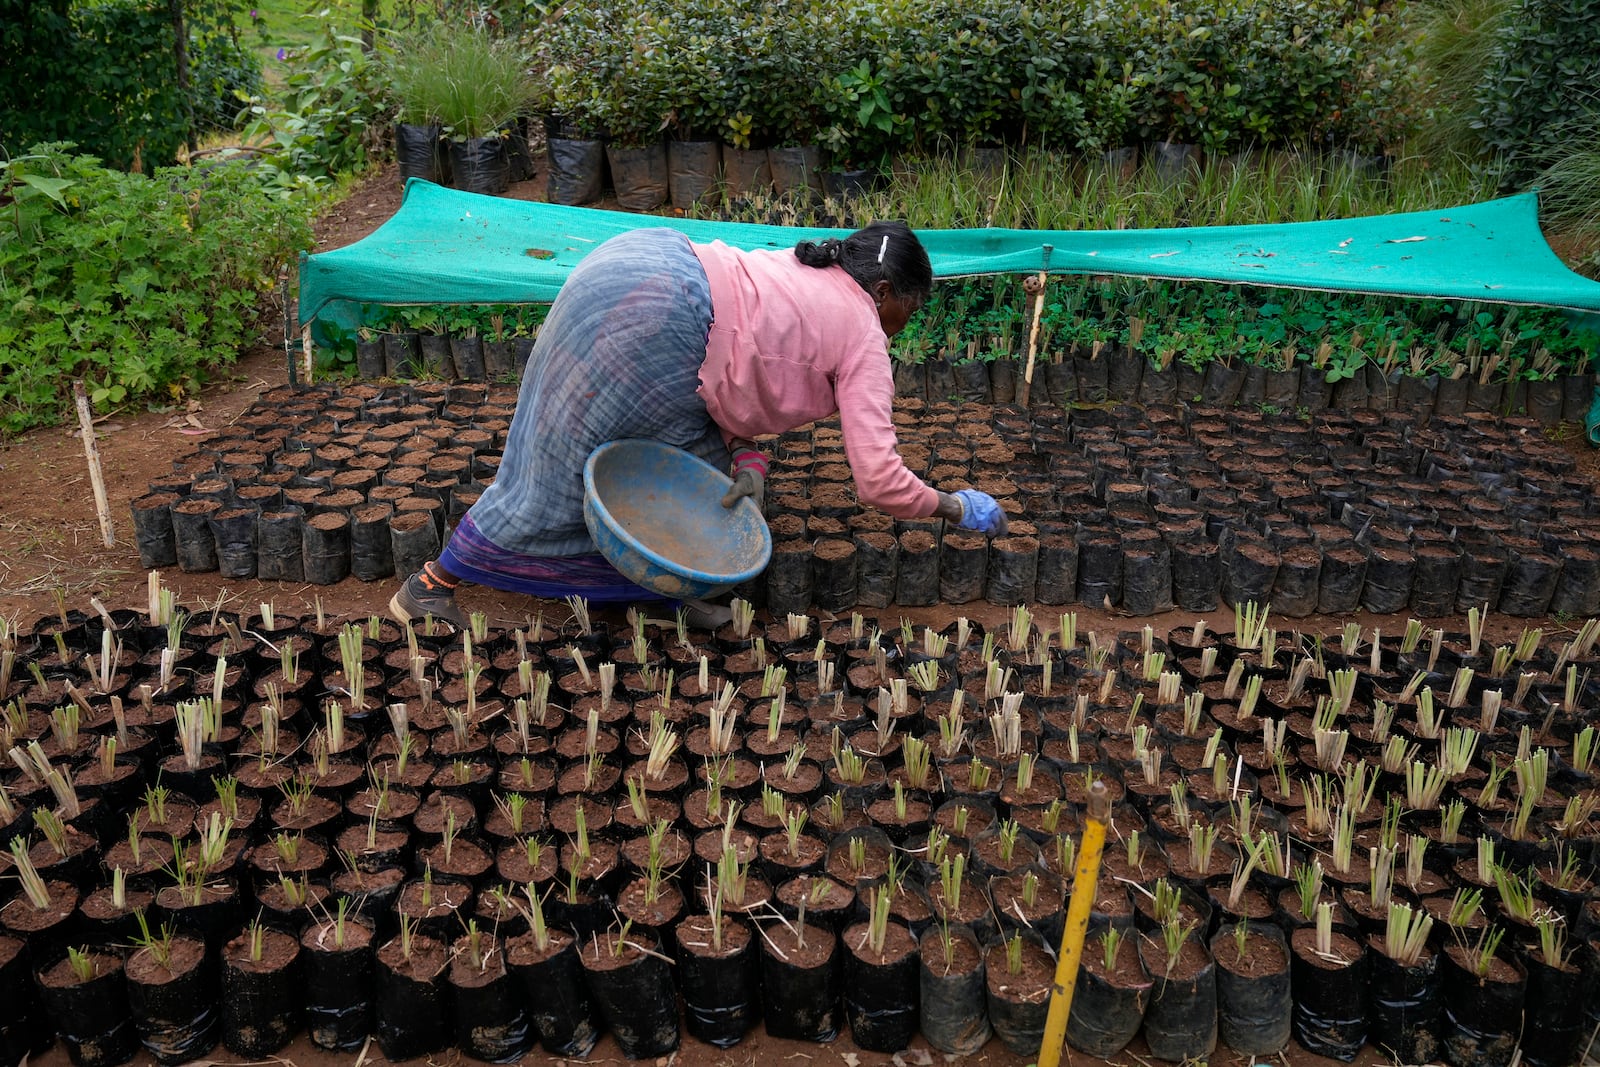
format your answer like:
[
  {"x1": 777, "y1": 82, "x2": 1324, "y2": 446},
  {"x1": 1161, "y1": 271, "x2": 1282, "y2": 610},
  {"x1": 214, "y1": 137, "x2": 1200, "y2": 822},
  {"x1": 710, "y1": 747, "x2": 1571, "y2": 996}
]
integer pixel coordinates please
[{"x1": 134, "y1": 384, "x2": 1600, "y2": 617}]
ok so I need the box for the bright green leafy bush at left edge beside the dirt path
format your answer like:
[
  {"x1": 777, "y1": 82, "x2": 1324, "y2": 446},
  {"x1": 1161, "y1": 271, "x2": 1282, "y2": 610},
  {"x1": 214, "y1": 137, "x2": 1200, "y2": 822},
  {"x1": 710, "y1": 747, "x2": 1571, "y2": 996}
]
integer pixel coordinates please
[{"x1": 0, "y1": 144, "x2": 310, "y2": 434}]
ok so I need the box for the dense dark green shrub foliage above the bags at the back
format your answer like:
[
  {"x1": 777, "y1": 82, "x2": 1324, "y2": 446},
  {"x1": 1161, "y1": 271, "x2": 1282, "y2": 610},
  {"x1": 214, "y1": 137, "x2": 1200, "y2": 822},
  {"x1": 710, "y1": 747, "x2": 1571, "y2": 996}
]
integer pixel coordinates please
[{"x1": 533, "y1": 0, "x2": 1408, "y2": 163}]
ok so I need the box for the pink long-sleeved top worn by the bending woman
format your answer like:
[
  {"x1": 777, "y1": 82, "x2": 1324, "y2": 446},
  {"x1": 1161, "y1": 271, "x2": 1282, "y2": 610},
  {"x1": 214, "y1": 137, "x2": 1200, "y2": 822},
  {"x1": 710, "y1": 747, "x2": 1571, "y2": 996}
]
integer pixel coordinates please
[{"x1": 694, "y1": 242, "x2": 939, "y2": 518}]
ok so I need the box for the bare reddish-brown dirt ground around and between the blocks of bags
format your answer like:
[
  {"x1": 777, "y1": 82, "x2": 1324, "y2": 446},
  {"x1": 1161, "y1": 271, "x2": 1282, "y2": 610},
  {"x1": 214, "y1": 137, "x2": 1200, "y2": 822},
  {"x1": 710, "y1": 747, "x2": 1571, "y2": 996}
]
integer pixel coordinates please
[{"x1": 0, "y1": 156, "x2": 1600, "y2": 1067}]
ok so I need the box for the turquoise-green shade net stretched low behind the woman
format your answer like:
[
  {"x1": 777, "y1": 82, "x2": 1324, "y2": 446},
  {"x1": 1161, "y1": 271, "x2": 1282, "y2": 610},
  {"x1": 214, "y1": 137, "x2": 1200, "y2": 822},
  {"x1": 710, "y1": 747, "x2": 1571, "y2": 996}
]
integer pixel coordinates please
[{"x1": 299, "y1": 178, "x2": 1600, "y2": 326}]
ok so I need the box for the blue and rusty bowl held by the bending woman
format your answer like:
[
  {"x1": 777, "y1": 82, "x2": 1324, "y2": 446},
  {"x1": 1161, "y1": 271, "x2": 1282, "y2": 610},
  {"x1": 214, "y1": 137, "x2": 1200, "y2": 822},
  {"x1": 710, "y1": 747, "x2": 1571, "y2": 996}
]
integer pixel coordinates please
[{"x1": 584, "y1": 438, "x2": 773, "y2": 600}]
